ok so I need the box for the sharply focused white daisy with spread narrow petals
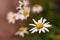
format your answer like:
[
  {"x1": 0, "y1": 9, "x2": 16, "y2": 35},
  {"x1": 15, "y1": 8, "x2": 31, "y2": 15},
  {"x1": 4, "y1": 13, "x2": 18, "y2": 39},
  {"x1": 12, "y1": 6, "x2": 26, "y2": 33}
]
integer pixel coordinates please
[{"x1": 29, "y1": 17, "x2": 51, "y2": 33}]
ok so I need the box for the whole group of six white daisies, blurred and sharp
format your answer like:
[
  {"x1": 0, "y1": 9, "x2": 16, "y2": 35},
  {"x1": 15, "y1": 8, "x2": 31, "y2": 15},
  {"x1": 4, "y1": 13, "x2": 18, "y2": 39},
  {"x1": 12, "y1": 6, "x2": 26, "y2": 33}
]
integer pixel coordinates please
[{"x1": 7, "y1": 0, "x2": 51, "y2": 37}]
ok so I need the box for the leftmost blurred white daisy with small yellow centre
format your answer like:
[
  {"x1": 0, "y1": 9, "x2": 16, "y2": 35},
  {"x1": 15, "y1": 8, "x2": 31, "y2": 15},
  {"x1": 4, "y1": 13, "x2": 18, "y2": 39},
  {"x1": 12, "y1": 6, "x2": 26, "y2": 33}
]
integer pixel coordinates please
[{"x1": 7, "y1": 12, "x2": 19, "y2": 24}]
